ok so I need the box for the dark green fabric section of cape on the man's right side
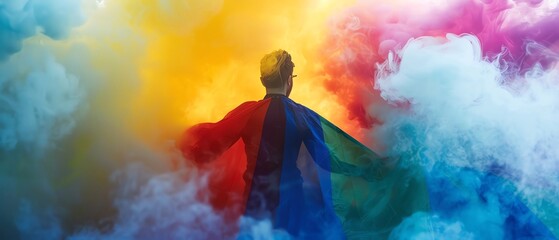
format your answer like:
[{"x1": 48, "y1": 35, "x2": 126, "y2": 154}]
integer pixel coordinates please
[{"x1": 321, "y1": 118, "x2": 429, "y2": 239}]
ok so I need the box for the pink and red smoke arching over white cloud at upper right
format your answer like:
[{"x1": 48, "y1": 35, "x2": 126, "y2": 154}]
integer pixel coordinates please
[{"x1": 321, "y1": 0, "x2": 559, "y2": 144}]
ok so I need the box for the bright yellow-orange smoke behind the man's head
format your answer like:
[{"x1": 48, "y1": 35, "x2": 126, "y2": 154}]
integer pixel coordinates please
[{"x1": 120, "y1": 0, "x2": 358, "y2": 142}]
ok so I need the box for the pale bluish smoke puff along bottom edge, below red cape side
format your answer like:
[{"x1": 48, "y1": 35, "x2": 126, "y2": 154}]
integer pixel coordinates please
[{"x1": 65, "y1": 160, "x2": 284, "y2": 239}]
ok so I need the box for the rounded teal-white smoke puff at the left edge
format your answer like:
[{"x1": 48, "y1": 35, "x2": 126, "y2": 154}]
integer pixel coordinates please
[{"x1": 0, "y1": 46, "x2": 85, "y2": 152}]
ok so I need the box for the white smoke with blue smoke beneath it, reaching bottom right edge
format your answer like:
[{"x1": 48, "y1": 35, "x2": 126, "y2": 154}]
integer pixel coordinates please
[{"x1": 374, "y1": 34, "x2": 559, "y2": 239}]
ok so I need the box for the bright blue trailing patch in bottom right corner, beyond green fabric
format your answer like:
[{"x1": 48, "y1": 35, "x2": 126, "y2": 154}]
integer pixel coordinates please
[{"x1": 427, "y1": 164, "x2": 556, "y2": 239}]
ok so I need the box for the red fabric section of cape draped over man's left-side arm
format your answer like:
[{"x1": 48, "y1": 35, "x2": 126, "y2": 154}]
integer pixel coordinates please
[{"x1": 178, "y1": 99, "x2": 270, "y2": 221}]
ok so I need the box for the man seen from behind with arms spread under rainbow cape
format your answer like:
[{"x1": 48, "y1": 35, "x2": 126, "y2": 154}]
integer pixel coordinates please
[{"x1": 179, "y1": 50, "x2": 428, "y2": 239}]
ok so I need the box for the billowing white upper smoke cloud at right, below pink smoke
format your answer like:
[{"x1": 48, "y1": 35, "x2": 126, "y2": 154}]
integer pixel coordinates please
[{"x1": 376, "y1": 35, "x2": 559, "y2": 180}]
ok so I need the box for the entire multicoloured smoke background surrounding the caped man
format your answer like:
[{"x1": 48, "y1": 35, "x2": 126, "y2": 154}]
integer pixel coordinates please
[{"x1": 0, "y1": 0, "x2": 559, "y2": 239}]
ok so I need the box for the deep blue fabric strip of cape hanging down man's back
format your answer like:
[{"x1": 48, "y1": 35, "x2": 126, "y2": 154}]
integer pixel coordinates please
[{"x1": 275, "y1": 98, "x2": 345, "y2": 239}]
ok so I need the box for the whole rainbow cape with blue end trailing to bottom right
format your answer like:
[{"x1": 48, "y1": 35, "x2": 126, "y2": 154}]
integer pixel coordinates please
[{"x1": 179, "y1": 94, "x2": 553, "y2": 239}]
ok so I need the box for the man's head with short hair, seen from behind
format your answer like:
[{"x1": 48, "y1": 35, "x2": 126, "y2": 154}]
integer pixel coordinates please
[{"x1": 260, "y1": 50, "x2": 295, "y2": 96}]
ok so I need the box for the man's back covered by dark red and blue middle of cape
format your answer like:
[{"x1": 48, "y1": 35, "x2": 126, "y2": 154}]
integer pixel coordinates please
[{"x1": 242, "y1": 94, "x2": 343, "y2": 237}]
